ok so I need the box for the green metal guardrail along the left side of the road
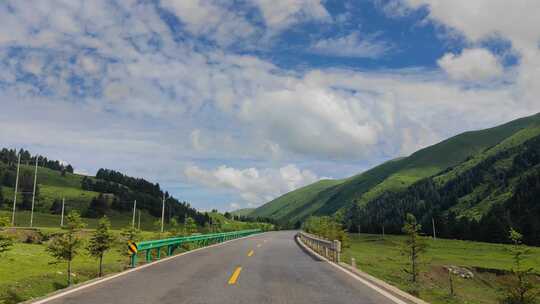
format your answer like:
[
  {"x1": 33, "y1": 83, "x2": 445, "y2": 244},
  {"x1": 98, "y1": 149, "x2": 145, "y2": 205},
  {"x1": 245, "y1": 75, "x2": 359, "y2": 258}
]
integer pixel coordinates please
[{"x1": 131, "y1": 229, "x2": 262, "y2": 267}]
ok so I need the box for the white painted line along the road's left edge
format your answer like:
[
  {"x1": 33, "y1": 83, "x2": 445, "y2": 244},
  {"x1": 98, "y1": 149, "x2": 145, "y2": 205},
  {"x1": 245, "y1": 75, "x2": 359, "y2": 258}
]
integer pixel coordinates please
[{"x1": 31, "y1": 232, "x2": 264, "y2": 304}]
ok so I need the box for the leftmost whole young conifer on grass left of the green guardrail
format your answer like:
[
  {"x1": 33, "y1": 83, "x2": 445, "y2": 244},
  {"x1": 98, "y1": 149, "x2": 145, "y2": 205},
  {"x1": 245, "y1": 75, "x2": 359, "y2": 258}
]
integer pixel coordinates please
[{"x1": 47, "y1": 211, "x2": 85, "y2": 286}]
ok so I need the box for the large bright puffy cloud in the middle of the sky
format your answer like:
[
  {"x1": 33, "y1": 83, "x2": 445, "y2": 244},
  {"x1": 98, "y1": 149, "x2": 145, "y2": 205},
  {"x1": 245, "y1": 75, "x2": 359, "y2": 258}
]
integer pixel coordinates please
[{"x1": 239, "y1": 79, "x2": 379, "y2": 158}]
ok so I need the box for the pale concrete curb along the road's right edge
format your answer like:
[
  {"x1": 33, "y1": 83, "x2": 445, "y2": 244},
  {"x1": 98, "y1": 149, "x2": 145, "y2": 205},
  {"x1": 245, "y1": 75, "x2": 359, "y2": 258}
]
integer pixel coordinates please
[{"x1": 295, "y1": 236, "x2": 429, "y2": 304}]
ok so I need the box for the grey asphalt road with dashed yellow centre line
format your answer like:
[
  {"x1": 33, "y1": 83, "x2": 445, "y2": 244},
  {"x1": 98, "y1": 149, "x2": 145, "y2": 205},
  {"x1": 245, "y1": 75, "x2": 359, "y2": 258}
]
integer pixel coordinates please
[{"x1": 47, "y1": 232, "x2": 393, "y2": 304}]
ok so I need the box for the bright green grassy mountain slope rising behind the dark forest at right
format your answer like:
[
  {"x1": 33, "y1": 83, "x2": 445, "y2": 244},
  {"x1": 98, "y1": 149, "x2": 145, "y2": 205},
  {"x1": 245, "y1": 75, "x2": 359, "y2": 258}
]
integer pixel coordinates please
[{"x1": 250, "y1": 114, "x2": 540, "y2": 223}]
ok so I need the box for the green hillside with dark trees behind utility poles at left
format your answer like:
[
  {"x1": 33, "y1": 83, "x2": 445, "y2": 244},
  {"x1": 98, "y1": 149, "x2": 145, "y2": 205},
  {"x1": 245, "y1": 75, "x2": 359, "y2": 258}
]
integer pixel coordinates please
[{"x1": 0, "y1": 156, "x2": 209, "y2": 229}]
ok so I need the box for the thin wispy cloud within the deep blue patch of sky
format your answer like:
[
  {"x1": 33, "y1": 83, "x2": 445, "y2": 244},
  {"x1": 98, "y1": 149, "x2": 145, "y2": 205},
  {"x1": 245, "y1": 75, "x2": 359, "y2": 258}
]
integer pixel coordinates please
[{"x1": 311, "y1": 33, "x2": 391, "y2": 58}]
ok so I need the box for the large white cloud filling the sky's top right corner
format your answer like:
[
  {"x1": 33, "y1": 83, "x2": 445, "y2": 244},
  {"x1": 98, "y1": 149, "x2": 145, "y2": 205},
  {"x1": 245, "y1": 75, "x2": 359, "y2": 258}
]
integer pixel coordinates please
[{"x1": 401, "y1": 0, "x2": 540, "y2": 109}]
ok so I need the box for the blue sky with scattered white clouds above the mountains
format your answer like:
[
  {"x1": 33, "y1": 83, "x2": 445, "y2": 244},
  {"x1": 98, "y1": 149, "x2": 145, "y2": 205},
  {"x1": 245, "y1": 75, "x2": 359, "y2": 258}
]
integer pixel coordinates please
[{"x1": 0, "y1": 0, "x2": 540, "y2": 210}]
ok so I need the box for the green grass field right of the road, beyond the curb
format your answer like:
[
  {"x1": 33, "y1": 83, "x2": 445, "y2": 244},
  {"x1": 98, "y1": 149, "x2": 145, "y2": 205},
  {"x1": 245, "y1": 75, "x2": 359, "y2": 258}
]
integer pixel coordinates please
[{"x1": 343, "y1": 234, "x2": 540, "y2": 304}]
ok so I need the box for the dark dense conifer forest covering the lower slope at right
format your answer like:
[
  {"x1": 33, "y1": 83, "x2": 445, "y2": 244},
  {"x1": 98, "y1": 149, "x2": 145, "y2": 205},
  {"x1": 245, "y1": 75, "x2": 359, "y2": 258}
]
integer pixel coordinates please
[{"x1": 344, "y1": 136, "x2": 540, "y2": 246}]
